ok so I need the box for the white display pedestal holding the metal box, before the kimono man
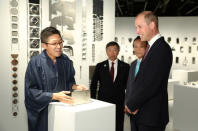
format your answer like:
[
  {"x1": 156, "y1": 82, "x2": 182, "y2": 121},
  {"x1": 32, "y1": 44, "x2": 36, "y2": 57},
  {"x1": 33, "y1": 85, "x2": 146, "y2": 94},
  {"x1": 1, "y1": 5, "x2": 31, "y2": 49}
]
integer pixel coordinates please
[{"x1": 48, "y1": 99, "x2": 115, "y2": 131}]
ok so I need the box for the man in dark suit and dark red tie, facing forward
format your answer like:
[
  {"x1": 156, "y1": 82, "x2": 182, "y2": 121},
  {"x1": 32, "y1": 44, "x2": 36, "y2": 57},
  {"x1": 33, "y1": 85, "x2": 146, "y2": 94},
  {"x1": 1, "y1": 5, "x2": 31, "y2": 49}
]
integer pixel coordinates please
[{"x1": 90, "y1": 41, "x2": 129, "y2": 131}]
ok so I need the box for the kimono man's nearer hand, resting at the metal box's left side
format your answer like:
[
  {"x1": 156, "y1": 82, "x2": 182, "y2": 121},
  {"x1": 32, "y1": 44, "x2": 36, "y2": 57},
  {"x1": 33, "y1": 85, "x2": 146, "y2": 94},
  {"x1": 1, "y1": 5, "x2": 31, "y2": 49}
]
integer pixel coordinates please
[{"x1": 52, "y1": 91, "x2": 73, "y2": 104}]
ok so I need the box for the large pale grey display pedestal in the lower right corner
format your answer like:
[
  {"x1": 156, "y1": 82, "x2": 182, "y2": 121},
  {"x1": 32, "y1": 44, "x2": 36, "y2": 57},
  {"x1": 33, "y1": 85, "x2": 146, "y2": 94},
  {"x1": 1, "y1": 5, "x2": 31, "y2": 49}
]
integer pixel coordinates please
[{"x1": 173, "y1": 85, "x2": 198, "y2": 131}]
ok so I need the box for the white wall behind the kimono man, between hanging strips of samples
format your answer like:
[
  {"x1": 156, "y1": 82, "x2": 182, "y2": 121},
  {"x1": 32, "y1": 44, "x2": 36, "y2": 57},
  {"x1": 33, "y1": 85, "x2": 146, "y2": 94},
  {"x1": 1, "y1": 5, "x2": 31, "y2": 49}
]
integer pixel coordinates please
[{"x1": 0, "y1": 0, "x2": 115, "y2": 131}]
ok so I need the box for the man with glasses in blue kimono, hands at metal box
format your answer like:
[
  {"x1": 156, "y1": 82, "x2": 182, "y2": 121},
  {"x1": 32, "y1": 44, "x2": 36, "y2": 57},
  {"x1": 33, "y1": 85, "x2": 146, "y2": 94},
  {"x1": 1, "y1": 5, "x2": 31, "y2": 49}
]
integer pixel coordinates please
[{"x1": 25, "y1": 27, "x2": 82, "y2": 131}]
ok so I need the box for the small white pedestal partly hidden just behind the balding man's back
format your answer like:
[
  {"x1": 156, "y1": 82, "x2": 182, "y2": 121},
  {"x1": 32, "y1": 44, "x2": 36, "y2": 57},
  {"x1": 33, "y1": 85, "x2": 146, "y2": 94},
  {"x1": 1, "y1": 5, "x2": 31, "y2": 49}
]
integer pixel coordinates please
[{"x1": 168, "y1": 79, "x2": 179, "y2": 100}]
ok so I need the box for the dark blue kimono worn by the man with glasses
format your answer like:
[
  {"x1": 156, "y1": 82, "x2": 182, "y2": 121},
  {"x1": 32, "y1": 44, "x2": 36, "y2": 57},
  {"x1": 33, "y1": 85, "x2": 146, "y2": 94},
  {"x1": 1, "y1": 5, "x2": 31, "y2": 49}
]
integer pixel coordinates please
[{"x1": 25, "y1": 50, "x2": 75, "y2": 131}]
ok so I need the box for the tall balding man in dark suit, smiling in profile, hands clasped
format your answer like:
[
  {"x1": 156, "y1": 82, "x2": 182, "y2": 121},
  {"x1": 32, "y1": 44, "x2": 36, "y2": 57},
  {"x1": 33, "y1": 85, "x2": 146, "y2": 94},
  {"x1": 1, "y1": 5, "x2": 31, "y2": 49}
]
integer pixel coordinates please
[{"x1": 125, "y1": 11, "x2": 172, "y2": 131}]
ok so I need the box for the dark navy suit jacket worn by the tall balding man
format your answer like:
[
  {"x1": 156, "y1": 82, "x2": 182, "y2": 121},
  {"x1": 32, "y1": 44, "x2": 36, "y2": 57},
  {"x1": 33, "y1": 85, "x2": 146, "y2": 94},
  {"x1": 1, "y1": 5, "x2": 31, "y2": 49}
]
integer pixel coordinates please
[{"x1": 126, "y1": 37, "x2": 172, "y2": 126}]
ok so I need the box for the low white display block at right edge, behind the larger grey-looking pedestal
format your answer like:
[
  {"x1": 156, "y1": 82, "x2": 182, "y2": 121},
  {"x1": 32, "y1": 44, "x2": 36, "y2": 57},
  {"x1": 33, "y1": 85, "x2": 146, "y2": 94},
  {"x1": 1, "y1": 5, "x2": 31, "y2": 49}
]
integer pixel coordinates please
[{"x1": 172, "y1": 70, "x2": 198, "y2": 84}]
